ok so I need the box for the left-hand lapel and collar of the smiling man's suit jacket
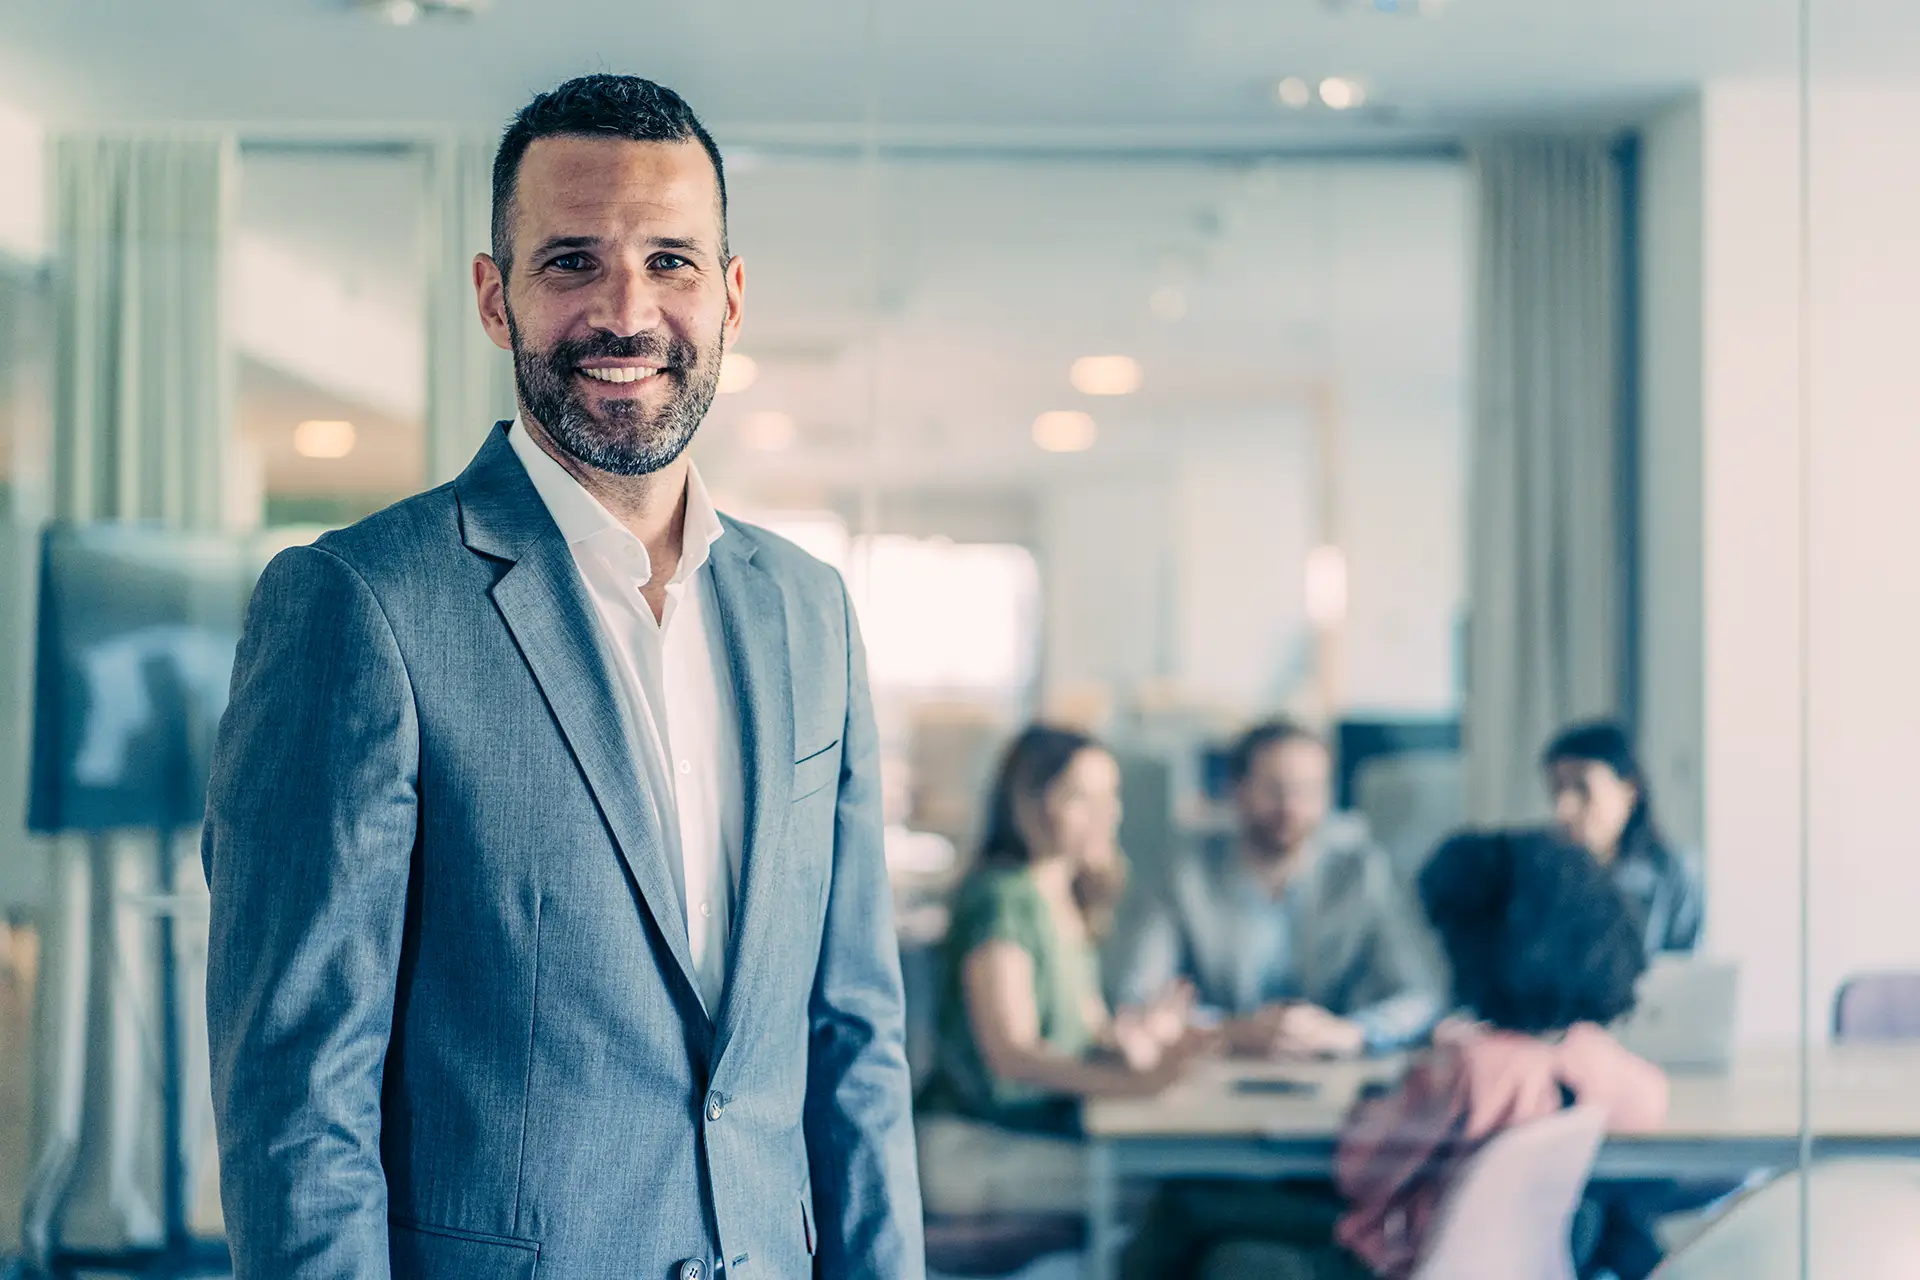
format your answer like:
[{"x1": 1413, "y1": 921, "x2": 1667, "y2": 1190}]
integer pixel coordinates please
[{"x1": 455, "y1": 428, "x2": 699, "y2": 1004}]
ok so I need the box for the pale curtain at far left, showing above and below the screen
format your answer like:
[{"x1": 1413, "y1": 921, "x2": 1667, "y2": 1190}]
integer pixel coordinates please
[{"x1": 21, "y1": 134, "x2": 236, "y2": 1257}]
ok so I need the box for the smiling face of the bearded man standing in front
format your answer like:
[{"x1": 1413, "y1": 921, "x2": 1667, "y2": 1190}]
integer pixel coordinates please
[{"x1": 474, "y1": 136, "x2": 745, "y2": 476}]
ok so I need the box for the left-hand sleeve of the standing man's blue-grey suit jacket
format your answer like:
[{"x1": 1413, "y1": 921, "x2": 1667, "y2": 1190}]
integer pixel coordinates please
[{"x1": 202, "y1": 547, "x2": 419, "y2": 1280}]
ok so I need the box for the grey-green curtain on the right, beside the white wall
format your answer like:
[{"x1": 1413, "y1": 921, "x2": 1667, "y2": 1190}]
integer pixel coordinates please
[{"x1": 1465, "y1": 138, "x2": 1626, "y2": 823}]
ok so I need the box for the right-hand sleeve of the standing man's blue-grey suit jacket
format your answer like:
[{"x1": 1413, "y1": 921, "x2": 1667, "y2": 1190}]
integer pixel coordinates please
[{"x1": 806, "y1": 575, "x2": 925, "y2": 1280}]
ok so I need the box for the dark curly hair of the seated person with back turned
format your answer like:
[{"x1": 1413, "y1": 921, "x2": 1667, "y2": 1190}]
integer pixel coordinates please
[{"x1": 1421, "y1": 831, "x2": 1647, "y2": 1034}]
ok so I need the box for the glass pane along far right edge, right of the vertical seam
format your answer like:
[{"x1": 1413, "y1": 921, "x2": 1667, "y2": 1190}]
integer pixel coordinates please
[{"x1": 1795, "y1": 0, "x2": 1920, "y2": 1276}]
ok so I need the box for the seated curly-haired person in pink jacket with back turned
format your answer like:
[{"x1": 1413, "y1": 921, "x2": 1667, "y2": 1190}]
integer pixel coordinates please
[{"x1": 1125, "y1": 833, "x2": 1667, "y2": 1280}]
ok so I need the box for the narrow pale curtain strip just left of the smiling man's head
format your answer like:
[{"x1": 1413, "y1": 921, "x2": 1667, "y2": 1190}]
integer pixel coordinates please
[{"x1": 426, "y1": 138, "x2": 515, "y2": 484}]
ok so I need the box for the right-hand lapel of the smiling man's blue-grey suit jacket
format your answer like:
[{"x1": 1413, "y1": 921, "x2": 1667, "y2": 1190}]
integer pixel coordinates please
[{"x1": 710, "y1": 530, "x2": 795, "y2": 1059}]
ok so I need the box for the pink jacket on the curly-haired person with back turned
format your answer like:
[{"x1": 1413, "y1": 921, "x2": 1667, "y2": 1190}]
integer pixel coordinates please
[{"x1": 1334, "y1": 1023, "x2": 1667, "y2": 1280}]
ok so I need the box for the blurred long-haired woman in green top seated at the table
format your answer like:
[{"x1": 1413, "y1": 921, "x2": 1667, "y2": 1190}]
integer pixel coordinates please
[{"x1": 920, "y1": 725, "x2": 1210, "y2": 1215}]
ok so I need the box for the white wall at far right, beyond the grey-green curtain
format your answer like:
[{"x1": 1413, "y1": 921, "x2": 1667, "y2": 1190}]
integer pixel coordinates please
[{"x1": 1642, "y1": 83, "x2": 1920, "y2": 1038}]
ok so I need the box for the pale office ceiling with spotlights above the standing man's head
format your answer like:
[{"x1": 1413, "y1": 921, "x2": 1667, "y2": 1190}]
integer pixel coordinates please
[{"x1": 0, "y1": 0, "x2": 1881, "y2": 144}]
